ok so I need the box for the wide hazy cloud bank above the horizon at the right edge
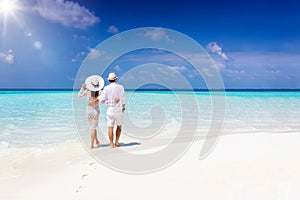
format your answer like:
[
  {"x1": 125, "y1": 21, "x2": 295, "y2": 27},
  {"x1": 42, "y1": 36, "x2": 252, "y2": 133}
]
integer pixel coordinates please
[{"x1": 222, "y1": 52, "x2": 300, "y2": 83}]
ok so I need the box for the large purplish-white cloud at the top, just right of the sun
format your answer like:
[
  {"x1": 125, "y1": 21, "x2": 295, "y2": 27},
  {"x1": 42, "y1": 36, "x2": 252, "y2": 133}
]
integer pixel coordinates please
[{"x1": 34, "y1": 0, "x2": 100, "y2": 29}]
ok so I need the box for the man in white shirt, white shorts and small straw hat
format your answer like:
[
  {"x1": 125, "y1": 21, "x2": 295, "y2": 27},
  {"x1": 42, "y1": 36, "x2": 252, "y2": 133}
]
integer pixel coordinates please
[{"x1": 99, "y1": 73, "x2": 125, "y2": 148}]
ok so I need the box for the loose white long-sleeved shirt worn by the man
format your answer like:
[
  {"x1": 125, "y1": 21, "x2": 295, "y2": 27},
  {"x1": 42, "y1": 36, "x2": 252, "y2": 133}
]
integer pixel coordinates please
[{"x1": 98, "y1": 82, "x2": 125, "y2": 114}]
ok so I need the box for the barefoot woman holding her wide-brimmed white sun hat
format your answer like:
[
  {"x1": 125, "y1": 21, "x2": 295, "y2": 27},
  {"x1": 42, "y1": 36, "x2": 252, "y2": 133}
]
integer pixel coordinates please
[{"x1": 78, "y1": 75, "x2": 104, "y2": 149}]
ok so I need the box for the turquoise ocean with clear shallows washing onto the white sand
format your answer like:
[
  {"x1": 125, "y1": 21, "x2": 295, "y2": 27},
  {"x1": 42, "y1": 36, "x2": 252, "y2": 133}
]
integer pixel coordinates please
[{"x1": 0, "y1": 91, "x2": 300, "y2": 177}]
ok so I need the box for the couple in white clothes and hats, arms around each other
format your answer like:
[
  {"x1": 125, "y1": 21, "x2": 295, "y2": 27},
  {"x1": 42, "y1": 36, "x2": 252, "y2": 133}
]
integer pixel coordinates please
[{"x1": 78, "y1": 73, "x2": 125, "y2": 149}]
